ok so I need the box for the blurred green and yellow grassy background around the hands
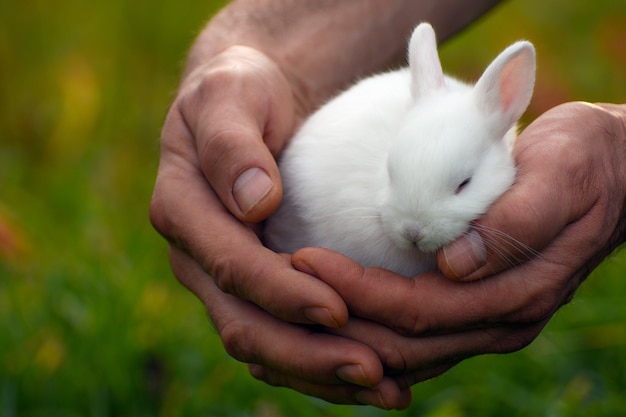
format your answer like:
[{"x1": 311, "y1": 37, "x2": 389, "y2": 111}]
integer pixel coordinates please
[{"x1": 0, "y1": 0, "x2": 626, "y2": 417}]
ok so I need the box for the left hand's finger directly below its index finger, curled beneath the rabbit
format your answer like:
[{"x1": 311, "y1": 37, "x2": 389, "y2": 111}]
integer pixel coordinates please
[{"x1": 171, "y1": 249, "x2": 382, "y2": 387}]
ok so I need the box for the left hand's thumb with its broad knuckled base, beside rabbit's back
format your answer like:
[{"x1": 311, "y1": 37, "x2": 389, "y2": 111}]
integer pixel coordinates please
[{"x1": 177, "y1": 47, "x2": 295, "y2": 222}]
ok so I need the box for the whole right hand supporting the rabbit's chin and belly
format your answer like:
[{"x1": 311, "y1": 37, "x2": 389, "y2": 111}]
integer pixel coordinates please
[{"x1": 292, "y1": 103, "x2": 626, "y2": 387}]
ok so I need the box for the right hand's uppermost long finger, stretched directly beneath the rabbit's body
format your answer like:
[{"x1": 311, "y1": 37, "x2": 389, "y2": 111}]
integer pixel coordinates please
[{"x1": 292, "y1": 245, "x2": 582, "y2": 335}]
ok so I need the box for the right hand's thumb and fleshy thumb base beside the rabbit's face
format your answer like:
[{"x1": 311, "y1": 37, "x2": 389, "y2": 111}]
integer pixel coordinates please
[{"x1": 438, "y1": 102, "x2": 626, "y2": 287}]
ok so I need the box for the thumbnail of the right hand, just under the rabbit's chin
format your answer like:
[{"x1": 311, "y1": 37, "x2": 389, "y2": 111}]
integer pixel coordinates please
[{"x1": 442, "y1": 229, "x2": 487, "y2": 280}]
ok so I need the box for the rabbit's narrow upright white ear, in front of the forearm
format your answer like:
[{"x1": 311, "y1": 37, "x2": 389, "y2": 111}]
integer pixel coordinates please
[{"x1": 409, "y1": 23, "x2": 444, "y2": 99}]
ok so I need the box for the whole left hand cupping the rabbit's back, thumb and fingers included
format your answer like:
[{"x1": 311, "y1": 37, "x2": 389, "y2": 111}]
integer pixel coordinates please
[{"x1": 151, "y1": 47, "x2": 410, "y2": 408}]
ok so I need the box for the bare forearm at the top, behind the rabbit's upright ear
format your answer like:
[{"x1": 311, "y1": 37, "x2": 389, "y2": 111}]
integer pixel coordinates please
[{"x1": 187, "y1": 0, "x2": 499, "y2": 112}]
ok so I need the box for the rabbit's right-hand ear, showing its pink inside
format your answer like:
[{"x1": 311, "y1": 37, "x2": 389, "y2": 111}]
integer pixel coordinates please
[{"x1": 474, "y1": 41, "x2": 535, "y2": 131}]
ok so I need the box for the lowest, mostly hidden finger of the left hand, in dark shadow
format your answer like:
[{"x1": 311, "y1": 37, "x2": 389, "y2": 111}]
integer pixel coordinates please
[{"x1": 249, "y1": 365, "x2": 411, "y2": 410}]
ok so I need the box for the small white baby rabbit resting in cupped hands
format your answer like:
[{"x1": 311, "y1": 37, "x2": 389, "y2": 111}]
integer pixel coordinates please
[{"x1": 264, "y1": 23, "x2": 535, "y2": 276}]
